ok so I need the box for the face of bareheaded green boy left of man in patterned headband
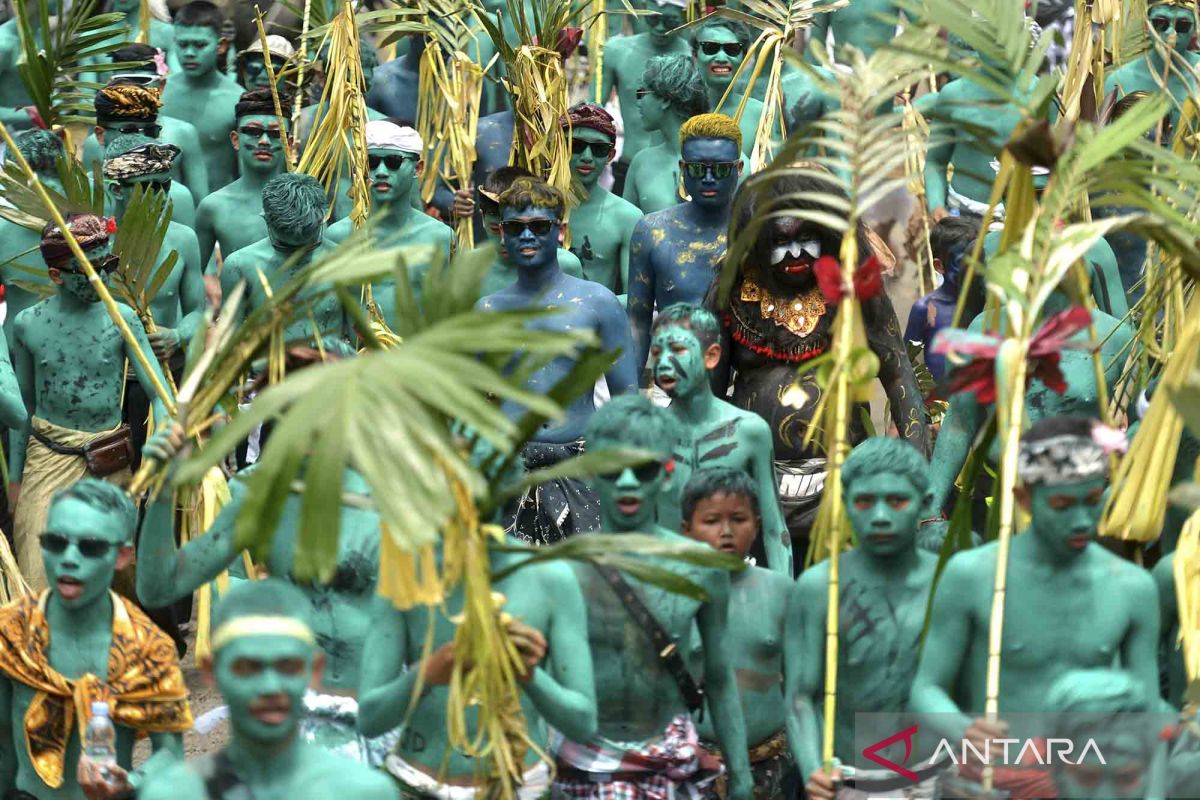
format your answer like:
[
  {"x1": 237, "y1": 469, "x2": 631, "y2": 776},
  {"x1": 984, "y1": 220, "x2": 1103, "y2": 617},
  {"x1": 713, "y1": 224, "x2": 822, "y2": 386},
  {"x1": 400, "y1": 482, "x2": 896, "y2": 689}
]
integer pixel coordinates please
[{"x1": 846, "y1": 473, "x2": 924, "y2": 557}]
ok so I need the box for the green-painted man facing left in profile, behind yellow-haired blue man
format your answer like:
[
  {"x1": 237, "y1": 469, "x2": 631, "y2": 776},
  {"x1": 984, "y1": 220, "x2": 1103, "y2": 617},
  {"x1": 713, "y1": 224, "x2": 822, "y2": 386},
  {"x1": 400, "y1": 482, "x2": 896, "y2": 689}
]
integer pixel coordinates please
[{"x1": 622, "y1": 55, "x2": 710, "y2": 213}]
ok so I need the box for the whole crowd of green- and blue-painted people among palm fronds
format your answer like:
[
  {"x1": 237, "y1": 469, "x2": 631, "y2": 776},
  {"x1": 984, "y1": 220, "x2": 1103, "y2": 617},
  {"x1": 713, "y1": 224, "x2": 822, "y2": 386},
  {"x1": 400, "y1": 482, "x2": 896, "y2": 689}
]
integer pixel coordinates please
[{"x1": 0, "y1": 0, "x2": 1200, "y2": 800}]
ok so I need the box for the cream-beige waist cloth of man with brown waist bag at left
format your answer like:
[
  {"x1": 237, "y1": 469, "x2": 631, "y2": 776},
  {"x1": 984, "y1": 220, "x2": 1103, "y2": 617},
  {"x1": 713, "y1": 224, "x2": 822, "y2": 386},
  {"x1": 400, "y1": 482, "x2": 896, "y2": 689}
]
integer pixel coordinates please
[{"x1": 13, "y1": 416, "x2": 132, "y2": 594}]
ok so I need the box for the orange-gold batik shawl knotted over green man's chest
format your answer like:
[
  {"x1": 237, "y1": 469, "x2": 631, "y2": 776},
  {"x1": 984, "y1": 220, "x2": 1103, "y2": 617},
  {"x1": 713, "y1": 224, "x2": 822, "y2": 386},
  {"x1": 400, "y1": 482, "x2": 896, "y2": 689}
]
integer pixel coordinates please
[{"x1": 0, "y1": 591, "x2": 192, "y2": 789}]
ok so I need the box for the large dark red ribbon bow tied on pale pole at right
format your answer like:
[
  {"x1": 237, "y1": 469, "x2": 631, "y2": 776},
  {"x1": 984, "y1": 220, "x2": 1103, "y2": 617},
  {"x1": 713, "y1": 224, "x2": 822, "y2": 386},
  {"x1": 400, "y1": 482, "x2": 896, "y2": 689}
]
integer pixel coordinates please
[{"x1": 934, "y1": 306, "x2": 1092, "y2": 404}]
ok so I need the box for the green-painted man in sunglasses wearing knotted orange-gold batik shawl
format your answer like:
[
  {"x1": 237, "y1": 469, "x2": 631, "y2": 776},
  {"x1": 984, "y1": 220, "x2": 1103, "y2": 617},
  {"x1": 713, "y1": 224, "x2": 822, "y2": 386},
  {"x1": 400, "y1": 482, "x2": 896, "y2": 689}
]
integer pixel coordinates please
[{"x1": 0, "y1": 479, "x2": 192, "y2": 800}]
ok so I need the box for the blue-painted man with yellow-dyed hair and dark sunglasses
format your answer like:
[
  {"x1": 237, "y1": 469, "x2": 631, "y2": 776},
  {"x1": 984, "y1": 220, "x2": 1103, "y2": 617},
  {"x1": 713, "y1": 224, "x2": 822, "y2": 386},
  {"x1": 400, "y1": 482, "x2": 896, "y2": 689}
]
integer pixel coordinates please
[{"x1": 629, "y1": 114, "x2": 744, "y2": 367}]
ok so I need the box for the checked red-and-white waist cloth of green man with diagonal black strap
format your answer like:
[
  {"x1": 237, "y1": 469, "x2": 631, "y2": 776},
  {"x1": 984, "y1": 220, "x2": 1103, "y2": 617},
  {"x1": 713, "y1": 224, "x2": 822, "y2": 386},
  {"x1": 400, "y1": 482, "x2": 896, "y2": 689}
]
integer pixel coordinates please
[{"x1": 550, "y1": 714, "x2": 721, "y2": 800}]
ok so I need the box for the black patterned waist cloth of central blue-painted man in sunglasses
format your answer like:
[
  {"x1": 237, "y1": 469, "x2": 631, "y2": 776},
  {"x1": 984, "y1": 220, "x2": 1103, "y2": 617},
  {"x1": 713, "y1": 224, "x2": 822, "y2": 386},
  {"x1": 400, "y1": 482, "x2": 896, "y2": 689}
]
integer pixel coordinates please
[{"x1": 505, "y1": 439, "x2": 600, "y2": 545}]
